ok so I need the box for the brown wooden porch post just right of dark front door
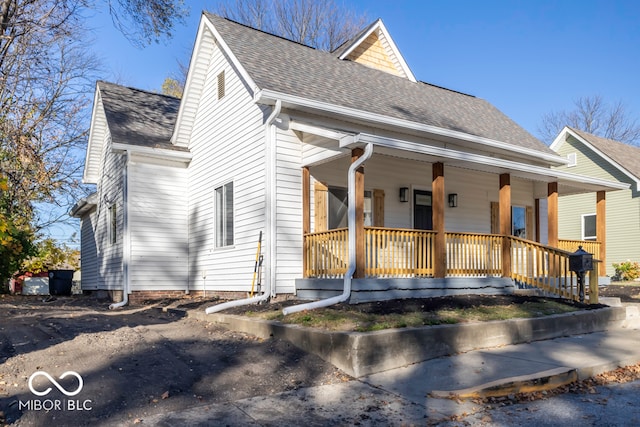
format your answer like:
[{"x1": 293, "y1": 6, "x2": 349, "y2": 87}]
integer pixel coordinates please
[{"x1": 431, "y1": 162, "x2": 447, "y2": 278}]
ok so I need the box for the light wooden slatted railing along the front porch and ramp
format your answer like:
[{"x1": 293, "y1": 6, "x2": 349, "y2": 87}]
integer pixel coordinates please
[{"x1": 304, "y1": 227, "x2": 599, "y2": 301}]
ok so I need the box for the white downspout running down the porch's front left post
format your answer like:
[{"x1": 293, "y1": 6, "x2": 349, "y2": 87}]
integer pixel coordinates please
[{"x1": 282, "y1": 143, "x2": 373, "y2": 316}]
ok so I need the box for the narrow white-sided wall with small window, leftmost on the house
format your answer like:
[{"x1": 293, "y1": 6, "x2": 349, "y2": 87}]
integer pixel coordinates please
[{"x1": 95, "y1": 136, "x2": 126, "y2": 290}]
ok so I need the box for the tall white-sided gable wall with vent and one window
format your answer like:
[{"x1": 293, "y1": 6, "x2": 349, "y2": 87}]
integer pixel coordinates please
[{"x1": 188, "y1": 40, "x2": 270, "y2": 292}]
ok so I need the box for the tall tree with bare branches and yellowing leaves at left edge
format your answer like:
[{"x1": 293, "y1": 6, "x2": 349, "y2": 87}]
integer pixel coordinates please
[{"x1": 0, "y1": 0, "x2": 189, "y2": 279}]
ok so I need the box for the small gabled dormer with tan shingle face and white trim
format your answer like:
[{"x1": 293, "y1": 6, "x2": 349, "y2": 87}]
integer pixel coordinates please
[{"x1": 336, "y1": 19, "x2": 416, "y2": 82}]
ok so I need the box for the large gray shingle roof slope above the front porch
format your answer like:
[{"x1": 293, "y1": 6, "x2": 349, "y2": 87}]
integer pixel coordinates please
[{"x1": 205, "y1": 12, "x2": 554, "y2": 154}]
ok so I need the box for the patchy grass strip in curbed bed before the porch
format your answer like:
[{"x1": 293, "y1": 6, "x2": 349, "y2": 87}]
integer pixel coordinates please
[{"x1": 245, "y1": 300, "x2": 579, "y2": 332}]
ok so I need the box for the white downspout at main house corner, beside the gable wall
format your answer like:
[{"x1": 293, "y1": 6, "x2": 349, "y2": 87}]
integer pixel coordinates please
[{"x1": 204, "y1": 99, "x2": 282, "y2": 314}]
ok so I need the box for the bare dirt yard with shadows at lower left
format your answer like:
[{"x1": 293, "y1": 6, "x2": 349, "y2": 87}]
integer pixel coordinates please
[{"x1": 0, "y1": 295, "x2": 349, "y2": 426}]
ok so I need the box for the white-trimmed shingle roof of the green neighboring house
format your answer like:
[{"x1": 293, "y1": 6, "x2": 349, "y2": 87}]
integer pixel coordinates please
[{"x1": 551, "y1": 126, "x2": 640, "y2": 190}]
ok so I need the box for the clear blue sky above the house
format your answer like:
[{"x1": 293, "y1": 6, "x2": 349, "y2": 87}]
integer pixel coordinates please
[{"x1": 89, "y1": 0, "x2": 640, "y2": 139}]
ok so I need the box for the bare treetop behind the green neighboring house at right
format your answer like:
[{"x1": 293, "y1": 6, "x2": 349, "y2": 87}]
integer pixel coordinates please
[{"x1": 538, "y1": 95, "x2": 640, "y2": 144}]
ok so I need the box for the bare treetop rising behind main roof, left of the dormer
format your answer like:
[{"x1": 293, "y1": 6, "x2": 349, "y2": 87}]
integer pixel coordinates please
[{"x1": 216, "y1": 0, "x2": 367, "y2": 51}]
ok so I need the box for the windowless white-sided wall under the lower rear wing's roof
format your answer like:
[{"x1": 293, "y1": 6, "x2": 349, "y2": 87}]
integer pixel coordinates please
[{"x1": 127, "y1": 158, "x2": 189, "y2": 291}]
